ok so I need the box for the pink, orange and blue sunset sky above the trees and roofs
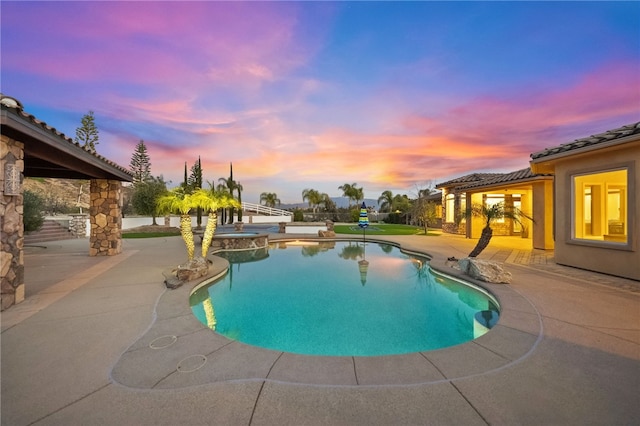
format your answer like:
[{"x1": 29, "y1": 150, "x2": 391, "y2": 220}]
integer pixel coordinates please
[{"x1": 0, "y1": 0, "x2": 640, "y2": 203}]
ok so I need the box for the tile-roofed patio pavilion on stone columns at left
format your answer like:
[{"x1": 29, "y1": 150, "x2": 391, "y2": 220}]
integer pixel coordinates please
[{"x1": 0, "y1": 94, "x2": 133, "y2": 310}]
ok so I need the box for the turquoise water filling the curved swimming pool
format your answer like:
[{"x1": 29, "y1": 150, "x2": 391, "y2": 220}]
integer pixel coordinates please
[{"x1": 190, "y1": 241, "x2": 498, "y2": 356}]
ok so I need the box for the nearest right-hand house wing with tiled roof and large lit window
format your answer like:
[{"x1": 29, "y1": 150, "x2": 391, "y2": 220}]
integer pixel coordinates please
[{"x1": 530, "y1": 122, "x2": 640, "y2": 280}]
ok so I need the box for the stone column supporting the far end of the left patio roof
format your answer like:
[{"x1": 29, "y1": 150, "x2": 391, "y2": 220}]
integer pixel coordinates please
[{"x1": 89, "y1": 179, "x2": 122, "y2": 256}]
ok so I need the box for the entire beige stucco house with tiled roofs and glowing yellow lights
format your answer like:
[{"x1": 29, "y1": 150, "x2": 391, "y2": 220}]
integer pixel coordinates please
[{"x1": 436, "y1": 122, "x2": 640, "y2": 280}]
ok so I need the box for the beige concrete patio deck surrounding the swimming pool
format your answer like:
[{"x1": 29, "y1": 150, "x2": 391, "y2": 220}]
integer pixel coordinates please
[{"x1": 0, "y1": 230, "x2": 640, "y2": 425}]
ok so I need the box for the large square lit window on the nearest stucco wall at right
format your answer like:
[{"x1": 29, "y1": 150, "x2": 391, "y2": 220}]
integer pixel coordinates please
[{"x1": 572, "y1": 169, "x2": 629, "y2": 244}]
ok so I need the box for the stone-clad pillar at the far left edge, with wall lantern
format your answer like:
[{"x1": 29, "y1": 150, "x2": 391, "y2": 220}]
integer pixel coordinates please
[{"x1": 0, "y1": 135, "x2": 24, "y2": 310}]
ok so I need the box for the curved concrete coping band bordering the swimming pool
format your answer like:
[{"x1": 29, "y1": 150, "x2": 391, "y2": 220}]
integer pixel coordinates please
[{"x1": 110, "y1": 234, "x2": 543, "y2": 389}]
